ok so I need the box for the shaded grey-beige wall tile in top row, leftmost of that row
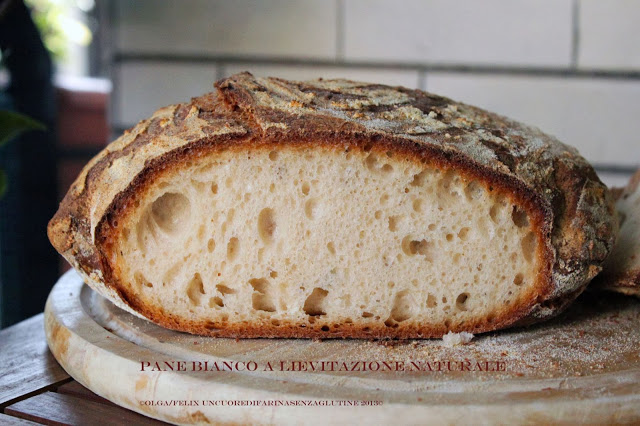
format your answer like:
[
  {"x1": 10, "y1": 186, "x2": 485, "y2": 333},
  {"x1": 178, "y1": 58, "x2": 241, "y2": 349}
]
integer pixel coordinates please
[{"x1": 114, "y1": 0, "x2": 337, "y2": 58}]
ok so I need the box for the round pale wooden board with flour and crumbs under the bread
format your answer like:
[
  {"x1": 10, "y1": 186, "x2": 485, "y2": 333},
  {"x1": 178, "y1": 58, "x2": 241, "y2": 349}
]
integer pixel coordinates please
[{"x1": 45, "y1": 271, "x2": 640, "y2": 424}]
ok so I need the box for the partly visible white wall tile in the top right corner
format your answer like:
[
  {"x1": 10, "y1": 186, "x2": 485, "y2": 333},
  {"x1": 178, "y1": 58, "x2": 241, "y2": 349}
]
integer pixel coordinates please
[{"x1": 578, "y1": 0, "x2": 640, "y2": 70}]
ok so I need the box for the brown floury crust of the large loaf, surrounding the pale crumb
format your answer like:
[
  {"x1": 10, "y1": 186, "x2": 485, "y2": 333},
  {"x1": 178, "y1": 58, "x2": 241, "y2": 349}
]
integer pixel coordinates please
[{"x1": 48, "y1": 73, "x2": 617, "y2": 338}]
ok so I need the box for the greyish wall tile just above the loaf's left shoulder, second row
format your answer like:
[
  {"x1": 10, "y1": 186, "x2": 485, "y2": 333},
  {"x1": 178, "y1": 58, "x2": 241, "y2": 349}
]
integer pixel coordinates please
[{"x1": 112, "y1": 62, "x2": 218, "y2": 127}]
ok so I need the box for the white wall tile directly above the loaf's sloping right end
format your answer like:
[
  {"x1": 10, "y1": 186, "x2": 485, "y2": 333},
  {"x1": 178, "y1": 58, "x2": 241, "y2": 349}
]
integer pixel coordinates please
[{"x1": 426, "y1": 73, "x2": 640, "y2": 166}]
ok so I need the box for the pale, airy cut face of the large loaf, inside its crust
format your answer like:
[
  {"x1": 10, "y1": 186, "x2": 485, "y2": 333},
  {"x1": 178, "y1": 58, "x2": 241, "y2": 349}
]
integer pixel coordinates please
[{"x1": 115, "y1": 147, "x2": 544, "y2": 333}]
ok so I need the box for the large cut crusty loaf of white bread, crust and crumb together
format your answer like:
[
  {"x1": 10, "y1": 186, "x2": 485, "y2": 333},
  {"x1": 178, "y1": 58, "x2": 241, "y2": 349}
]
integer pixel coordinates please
[{"x1": 49, "y1": 73, "x2": 617, "y2": 338}]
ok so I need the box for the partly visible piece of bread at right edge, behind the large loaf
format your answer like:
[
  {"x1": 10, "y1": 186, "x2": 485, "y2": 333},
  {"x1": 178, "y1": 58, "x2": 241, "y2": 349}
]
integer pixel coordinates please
[{"x1": 598, "y1": 170, "x2": 640, "y2": 297}]
